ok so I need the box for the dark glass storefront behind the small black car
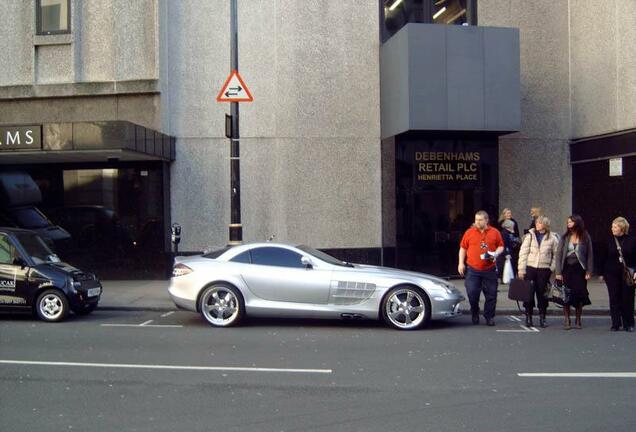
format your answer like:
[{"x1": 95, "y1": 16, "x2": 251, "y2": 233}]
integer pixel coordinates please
[{"x1": 15, "y1": 162, "x2": 169, "y2": 279}]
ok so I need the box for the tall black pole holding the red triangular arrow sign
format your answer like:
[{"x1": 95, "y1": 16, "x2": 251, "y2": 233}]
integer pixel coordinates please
[{"x1": 229, "y1": 0, "x2": 243, "y2": 245}]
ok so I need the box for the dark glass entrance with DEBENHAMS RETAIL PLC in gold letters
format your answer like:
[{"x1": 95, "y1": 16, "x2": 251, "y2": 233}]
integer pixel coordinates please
[{"x1": 388, "y1": 134, "x2": 499, "y2": 276}]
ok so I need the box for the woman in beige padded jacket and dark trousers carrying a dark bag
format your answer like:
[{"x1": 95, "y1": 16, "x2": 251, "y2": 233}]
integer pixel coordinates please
[{"x1": 518, "y1": 216, "x2": 559, "y2": 327}]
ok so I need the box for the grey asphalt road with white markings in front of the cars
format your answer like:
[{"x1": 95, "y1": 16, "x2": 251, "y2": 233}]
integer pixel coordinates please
[{"x1": 0, "y1": 311, "x2": 636, "y2": 431}]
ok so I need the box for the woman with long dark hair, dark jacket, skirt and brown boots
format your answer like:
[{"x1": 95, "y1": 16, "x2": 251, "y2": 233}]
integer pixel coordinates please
[{"x1": 555, "y1": 214, "x2": 594, "y2": 330}]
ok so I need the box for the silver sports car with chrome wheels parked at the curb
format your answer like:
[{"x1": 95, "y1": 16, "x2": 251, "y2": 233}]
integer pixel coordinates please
[{"x1": 169, "y1": 243, "x2": 464, "y2": 330}]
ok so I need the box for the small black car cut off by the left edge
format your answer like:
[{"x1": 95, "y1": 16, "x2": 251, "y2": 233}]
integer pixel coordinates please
[{"x1": 0, "y1": 227, "x2": 102, "y2": 322}]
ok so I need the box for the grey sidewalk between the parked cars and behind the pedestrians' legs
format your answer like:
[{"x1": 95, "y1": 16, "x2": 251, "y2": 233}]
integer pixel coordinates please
[{"x1": 99, "y1": 278, "x2": 609, "y2": 315}]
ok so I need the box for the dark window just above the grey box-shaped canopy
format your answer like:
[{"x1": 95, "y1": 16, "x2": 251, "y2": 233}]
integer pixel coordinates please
[{"x1": 380, "y1": 0, "x2": 477, "y2": 42}]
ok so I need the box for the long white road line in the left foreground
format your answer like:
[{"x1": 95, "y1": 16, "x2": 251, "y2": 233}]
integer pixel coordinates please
[{"x1": 0, "y1": 360, "x2": 333, "y2": 374}]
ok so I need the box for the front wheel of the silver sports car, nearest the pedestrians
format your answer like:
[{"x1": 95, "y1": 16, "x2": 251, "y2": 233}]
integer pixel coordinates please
[{"x1": 382, "y1": 286, "x2": 431, "y2": 330}]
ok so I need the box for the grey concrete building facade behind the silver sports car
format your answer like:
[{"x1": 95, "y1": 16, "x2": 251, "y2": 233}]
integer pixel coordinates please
[{"x1": 0, "y1": 0, "x2": 636, "y2": 276}]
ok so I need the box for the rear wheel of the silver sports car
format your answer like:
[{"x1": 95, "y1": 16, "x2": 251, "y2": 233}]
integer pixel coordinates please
[{"x1": 199, "y1": 284, "x2": 245, "y2": 327}]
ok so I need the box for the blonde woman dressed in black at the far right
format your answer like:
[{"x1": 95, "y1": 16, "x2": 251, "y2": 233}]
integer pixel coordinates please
[{"x1": 600, "y1": 217, "x2": 636, "y2": 332}]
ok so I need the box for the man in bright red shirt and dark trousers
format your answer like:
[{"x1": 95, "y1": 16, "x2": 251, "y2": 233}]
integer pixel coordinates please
[{"x1": 457, "y1": 210, "x2": 504, "y2": 326}]
